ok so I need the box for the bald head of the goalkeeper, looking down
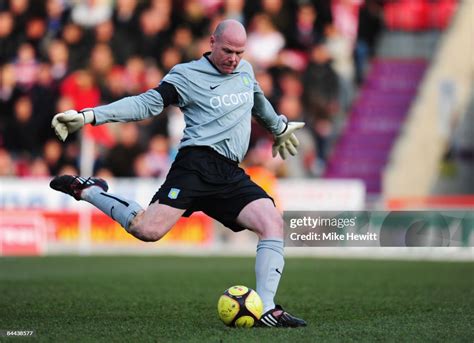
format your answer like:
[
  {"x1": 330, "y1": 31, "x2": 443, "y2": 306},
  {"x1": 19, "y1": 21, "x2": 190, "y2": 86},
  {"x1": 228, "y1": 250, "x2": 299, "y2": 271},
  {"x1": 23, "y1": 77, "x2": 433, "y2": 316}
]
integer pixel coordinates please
[{"x1": 209, "y1": 19, "x2": 247, "y2": 74}]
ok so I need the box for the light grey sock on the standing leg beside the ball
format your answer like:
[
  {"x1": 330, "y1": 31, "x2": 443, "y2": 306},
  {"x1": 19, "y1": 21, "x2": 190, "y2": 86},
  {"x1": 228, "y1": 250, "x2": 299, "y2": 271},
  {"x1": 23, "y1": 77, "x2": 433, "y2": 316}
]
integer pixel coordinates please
[{"x1": 255, "y1": 239, "x2": 285, "y2": 313}]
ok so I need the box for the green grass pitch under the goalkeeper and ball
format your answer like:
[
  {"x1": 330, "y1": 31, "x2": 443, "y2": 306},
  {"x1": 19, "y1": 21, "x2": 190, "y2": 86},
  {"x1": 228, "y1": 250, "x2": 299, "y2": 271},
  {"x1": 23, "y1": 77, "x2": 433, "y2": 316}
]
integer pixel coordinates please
[{"x1": 0, "y1": 256, "x2": 474, "y2": 343}]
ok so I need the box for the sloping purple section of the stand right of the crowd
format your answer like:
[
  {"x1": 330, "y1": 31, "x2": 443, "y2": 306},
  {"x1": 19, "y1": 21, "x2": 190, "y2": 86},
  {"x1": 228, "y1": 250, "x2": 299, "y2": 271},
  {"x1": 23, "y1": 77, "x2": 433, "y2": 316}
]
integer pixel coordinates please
[{"x1": 324, "y1": 59, "x2": 426, "y2": 193}]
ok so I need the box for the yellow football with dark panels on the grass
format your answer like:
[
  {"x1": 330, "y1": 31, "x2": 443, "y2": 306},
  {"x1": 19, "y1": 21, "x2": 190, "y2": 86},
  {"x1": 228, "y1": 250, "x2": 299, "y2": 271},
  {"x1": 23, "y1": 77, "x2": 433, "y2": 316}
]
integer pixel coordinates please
[{"x1": 217, "y1": 286, "x2": 263, "y2": 328}]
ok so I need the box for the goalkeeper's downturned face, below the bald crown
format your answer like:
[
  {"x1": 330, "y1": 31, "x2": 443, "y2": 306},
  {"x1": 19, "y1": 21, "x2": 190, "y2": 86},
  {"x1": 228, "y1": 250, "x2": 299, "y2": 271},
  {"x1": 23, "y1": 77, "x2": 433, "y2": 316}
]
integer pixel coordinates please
[{"x1": 210, "y1": 35, "x2": 245, "y2": 74}]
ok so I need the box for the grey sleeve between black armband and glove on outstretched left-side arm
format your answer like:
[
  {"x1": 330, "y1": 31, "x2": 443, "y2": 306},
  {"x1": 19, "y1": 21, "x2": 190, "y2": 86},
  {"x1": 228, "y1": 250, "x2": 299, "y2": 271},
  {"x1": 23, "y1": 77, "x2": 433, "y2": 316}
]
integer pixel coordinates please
[{"x1": 93, "y1": 89, "x2": 164, "y2": 125}]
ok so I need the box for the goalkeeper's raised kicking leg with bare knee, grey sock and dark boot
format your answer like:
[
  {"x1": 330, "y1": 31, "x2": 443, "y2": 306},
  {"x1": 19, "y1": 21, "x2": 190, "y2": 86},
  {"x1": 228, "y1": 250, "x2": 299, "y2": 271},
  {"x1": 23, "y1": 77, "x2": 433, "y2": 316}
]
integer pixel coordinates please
[{"x1": 50, "y1": 175, "x2": 185, "y2": 242}]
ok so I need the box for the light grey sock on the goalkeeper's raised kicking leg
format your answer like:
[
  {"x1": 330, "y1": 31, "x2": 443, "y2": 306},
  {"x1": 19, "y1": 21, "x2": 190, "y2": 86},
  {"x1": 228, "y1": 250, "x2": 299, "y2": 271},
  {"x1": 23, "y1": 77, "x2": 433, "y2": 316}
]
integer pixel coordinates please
[{"x1": 82, "y1": 187, "x2": 143, "y2": 232}]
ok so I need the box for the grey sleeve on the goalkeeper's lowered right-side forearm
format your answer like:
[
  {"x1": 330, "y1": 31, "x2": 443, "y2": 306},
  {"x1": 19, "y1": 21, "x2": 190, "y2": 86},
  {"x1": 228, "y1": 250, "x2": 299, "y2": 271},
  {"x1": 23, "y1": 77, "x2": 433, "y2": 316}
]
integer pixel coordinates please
[{"x1": 252, "y1": 92, "x2": 286, "y2": 136}]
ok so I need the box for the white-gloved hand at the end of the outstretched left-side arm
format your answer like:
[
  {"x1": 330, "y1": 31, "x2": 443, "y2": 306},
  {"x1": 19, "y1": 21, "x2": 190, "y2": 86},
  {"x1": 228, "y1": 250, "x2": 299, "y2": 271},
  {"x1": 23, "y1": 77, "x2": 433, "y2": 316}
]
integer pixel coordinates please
[{"x1": 51, "y1": 109, "x2": 94, "y2": 142}]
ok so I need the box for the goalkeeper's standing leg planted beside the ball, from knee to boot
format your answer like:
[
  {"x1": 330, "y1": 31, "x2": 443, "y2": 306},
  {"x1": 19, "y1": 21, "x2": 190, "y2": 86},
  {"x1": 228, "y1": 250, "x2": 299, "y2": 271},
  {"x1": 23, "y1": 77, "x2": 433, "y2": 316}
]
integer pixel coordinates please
[{"x1": 237, "y1": 199, "x2": 306, "y2": 327}]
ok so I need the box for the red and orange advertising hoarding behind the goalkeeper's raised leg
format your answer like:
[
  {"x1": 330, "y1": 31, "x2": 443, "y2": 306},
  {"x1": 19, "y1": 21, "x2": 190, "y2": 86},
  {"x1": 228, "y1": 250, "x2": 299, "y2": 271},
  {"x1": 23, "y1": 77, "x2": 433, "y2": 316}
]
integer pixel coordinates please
[{"x1": 0, "y1": 210, "x2": 213, "y2": 256}]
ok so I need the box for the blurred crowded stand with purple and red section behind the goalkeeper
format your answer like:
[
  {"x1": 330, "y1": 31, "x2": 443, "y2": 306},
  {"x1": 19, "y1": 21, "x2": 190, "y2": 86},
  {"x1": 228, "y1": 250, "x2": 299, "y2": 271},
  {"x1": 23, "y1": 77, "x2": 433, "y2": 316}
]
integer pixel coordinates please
[{"x1": 0, "y1": 0, "x2": 466, "y2": 202}]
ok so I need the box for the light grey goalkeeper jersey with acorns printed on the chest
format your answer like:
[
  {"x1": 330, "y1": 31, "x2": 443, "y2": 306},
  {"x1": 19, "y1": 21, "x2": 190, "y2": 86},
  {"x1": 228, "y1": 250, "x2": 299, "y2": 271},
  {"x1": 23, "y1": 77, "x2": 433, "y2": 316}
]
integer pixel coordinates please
[{"x1": 94, "y1": 56, "x2": 286, "y2": 162}]
